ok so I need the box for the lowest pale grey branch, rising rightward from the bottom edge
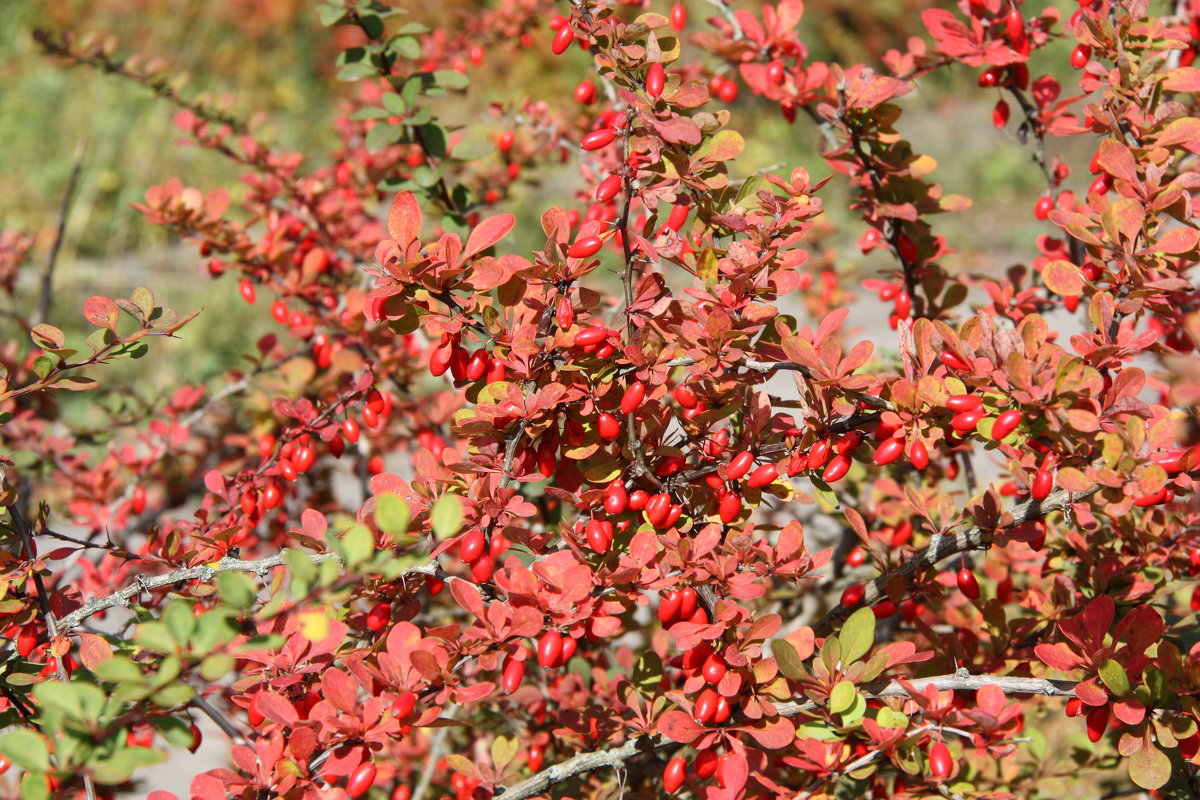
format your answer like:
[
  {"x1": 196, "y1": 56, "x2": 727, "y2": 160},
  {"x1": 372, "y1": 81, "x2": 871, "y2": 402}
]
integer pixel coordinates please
[{"x1": 496, "y1": 670, "x2": 1075, "y2": 800}]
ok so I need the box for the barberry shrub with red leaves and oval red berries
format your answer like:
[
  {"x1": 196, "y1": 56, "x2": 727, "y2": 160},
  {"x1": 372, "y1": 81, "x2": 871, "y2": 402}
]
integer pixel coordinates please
[{"x1": 0, "y1": 0, "x2": 1200, "y2": 800}]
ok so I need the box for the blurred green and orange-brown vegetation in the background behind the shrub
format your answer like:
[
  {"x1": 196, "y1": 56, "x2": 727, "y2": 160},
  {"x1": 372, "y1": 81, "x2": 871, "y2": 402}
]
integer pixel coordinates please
[{"x1": 0, "y1": 0, "x2": 1088, "y2": 387}]
